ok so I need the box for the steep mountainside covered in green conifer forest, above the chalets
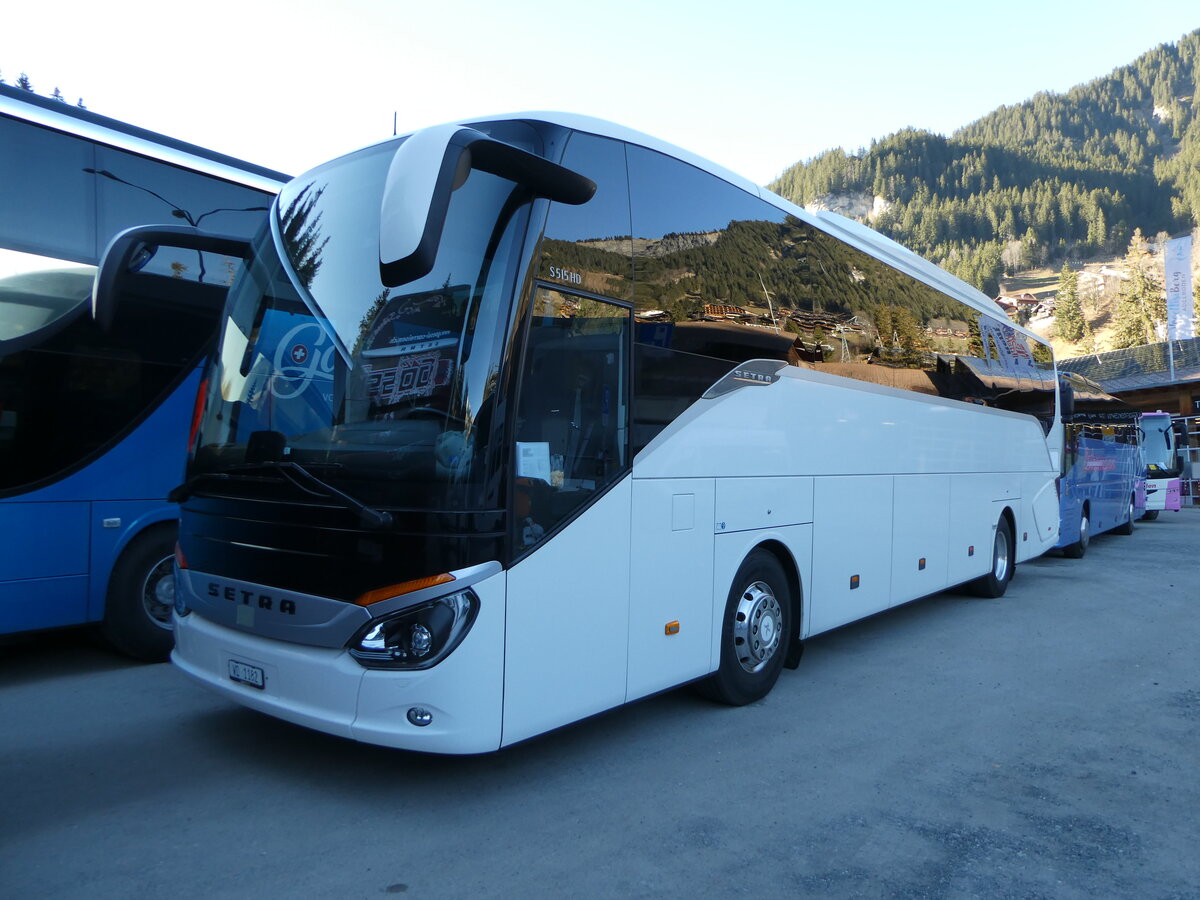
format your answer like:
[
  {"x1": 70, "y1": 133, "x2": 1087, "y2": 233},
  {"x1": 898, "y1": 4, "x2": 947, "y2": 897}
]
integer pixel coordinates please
[{"x1": 770, "y1": 30, "x2": 1200, "y2": 296}]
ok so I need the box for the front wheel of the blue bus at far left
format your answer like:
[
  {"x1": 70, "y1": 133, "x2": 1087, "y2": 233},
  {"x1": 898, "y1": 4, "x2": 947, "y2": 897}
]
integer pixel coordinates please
[{"x1": 100, "y1": 526, "x2": 175, "y2": 662}]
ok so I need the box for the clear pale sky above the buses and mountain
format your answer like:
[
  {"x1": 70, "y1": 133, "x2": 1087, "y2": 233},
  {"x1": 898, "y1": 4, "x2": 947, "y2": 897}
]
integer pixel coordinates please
[{"x1": 0, "y1": 0, "x2": 1200, "y2": 182}]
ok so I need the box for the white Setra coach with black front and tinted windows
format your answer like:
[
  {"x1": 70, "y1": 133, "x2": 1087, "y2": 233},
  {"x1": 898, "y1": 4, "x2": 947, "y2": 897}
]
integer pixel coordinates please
[{"x1": 98, "y1": 113, "x2": 1062, "y2": 754}]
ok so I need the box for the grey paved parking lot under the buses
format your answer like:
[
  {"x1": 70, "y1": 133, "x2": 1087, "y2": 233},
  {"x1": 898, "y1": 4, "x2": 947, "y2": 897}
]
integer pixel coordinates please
[{"x1": 0, "y1": 510, "x2": 1200, "y2": 898}]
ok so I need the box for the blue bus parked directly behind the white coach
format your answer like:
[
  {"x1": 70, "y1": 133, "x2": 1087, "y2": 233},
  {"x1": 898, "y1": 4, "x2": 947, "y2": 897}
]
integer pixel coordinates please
[{"x1": 1055, "y1": 372, "x2": 1146, "y2": 559}]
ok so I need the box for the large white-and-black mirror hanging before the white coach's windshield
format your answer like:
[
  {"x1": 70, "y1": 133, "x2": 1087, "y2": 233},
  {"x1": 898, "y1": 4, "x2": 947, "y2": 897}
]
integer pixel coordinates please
[{"x1": 379, "y1": 125, "x2": 596, "y2": 288}]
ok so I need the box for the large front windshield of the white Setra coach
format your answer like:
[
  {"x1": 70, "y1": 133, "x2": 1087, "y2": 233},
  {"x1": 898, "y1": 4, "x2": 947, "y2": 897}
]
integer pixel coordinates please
[{"x1": 192, "y1": 124, "x2": 533, "y2": 509}]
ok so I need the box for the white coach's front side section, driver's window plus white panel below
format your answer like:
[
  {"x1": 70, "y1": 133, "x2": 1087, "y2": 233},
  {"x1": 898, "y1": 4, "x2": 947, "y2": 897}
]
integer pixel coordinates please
[{"x1": 502, "y1": 287, "x2": 632, "y2": 744}]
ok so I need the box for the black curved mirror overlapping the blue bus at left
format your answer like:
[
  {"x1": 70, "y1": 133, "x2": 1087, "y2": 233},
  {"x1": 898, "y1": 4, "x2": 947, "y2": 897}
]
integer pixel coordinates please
[{"x1": 91, "y1": 226, "x2": 250, "y2": 331}]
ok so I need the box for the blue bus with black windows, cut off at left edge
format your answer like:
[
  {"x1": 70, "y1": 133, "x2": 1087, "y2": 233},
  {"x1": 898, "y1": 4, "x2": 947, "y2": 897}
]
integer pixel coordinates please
[{"x1": 0, "y1": 85, "x2": 287, "y2": 660}]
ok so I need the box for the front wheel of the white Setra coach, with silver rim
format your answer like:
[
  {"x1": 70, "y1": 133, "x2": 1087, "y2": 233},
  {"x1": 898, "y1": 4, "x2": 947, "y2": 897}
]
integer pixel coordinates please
[{"x1": 697, "y1": 550, "x2": 793, "y2": 706}]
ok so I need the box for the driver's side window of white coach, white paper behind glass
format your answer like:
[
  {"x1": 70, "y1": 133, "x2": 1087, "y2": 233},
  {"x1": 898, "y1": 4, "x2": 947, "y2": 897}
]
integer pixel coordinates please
[{"x1": 512, "y1": 287, "x2": 631, "y2": 553}]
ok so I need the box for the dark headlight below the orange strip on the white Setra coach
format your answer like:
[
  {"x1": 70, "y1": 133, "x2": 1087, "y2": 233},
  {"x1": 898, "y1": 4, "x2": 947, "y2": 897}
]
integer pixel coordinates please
[{"x1": 349, "y1": 590, "x2": 479, "y2": 668}]
